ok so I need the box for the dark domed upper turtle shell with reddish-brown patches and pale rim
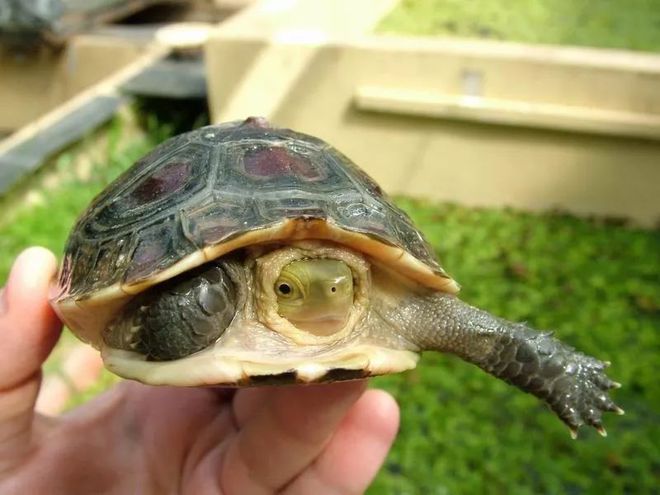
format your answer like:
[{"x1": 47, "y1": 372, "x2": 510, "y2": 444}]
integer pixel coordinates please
[{"x1": 54, "y1": 118, "x2": 458, "y2": 346}]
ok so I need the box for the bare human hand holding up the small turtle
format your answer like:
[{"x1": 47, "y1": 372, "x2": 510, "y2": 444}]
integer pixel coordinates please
[{"x1": 0, "y1": 248, "x2": 399, "y2": 495}]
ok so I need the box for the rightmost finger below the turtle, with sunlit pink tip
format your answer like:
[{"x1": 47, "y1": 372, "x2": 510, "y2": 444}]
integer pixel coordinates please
[{"x1": 284, "y1": 390, "x2": 399, "y2": 495}]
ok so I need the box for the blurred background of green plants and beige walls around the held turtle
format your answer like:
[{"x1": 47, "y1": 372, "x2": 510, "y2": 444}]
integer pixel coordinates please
[{"x1": 0, "y1": 0, "x2": 660, "y2": 494}]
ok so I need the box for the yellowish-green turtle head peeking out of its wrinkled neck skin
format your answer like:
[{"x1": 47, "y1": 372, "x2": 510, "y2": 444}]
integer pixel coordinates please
[{"x1": 274, "y1": 258, "x2": 353, "y2": 335}]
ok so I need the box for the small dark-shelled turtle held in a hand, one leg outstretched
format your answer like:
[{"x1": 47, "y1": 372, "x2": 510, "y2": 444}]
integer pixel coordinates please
[{"x1": 51, "y1": 117, "x2": 623, "y2": 436}]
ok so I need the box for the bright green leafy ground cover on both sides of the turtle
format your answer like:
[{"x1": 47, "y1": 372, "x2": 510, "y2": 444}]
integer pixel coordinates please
[{"x1": 0, "y1": 104, "x2": 660, "y2": 495}]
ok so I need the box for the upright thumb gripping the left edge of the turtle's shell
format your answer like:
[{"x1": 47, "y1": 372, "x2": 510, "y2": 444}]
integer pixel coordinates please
[{"x1": 0, "y1": 248, "x2": 61, "y2": 474}]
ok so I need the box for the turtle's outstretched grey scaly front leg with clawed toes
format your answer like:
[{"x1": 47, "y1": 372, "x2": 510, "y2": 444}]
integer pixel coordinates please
[{"x1": 381, "y1": 293, "x2": 623, "y2": 438}]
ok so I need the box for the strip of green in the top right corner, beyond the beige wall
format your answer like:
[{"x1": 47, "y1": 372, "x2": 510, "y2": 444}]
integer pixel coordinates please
[{"x1": 378, "y1": 0, "x2": 660, "y2": 51}]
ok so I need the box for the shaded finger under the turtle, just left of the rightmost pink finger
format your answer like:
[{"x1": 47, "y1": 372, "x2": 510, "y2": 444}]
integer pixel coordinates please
[{"x1": 219, "y1": 381, "x2": 366, "y2": 494}]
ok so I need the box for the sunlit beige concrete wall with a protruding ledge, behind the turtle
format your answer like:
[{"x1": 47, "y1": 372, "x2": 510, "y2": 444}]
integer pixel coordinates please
[{"x1": 207, "y1": 0, "x2": 660, "y2": 225}]
